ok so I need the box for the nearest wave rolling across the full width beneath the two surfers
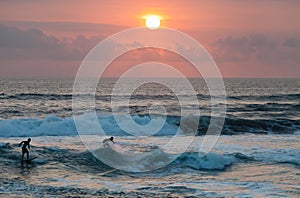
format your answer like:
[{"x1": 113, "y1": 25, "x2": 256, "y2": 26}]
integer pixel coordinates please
[{"x1": 0, "y1": 143, "x2": 300, "y2": 174}]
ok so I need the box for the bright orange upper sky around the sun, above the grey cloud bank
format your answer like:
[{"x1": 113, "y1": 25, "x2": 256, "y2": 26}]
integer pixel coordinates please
[{"x1": 0, "y1": 0, "x2": 300, "y2": 31}]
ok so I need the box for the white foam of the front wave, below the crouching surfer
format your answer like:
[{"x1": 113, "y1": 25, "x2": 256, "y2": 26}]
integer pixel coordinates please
[{"x1": 93, "y1": 144, "x2": 238, "y2": 172}]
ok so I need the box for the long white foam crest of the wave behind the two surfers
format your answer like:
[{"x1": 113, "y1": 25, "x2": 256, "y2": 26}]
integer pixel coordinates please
[{"x1": 0, "y1": 113, "x2": 178, "y2": 137}]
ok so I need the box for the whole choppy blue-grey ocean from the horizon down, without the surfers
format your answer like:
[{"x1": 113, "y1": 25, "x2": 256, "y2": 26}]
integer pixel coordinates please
[{"x1": 0, "y1": 79, "x2": 300, "y2": 197}]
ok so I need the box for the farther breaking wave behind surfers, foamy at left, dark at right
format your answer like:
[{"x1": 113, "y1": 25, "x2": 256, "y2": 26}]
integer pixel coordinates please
[{"x1": 0, "y1": 113, "x2": 300, "y2": 137}]
